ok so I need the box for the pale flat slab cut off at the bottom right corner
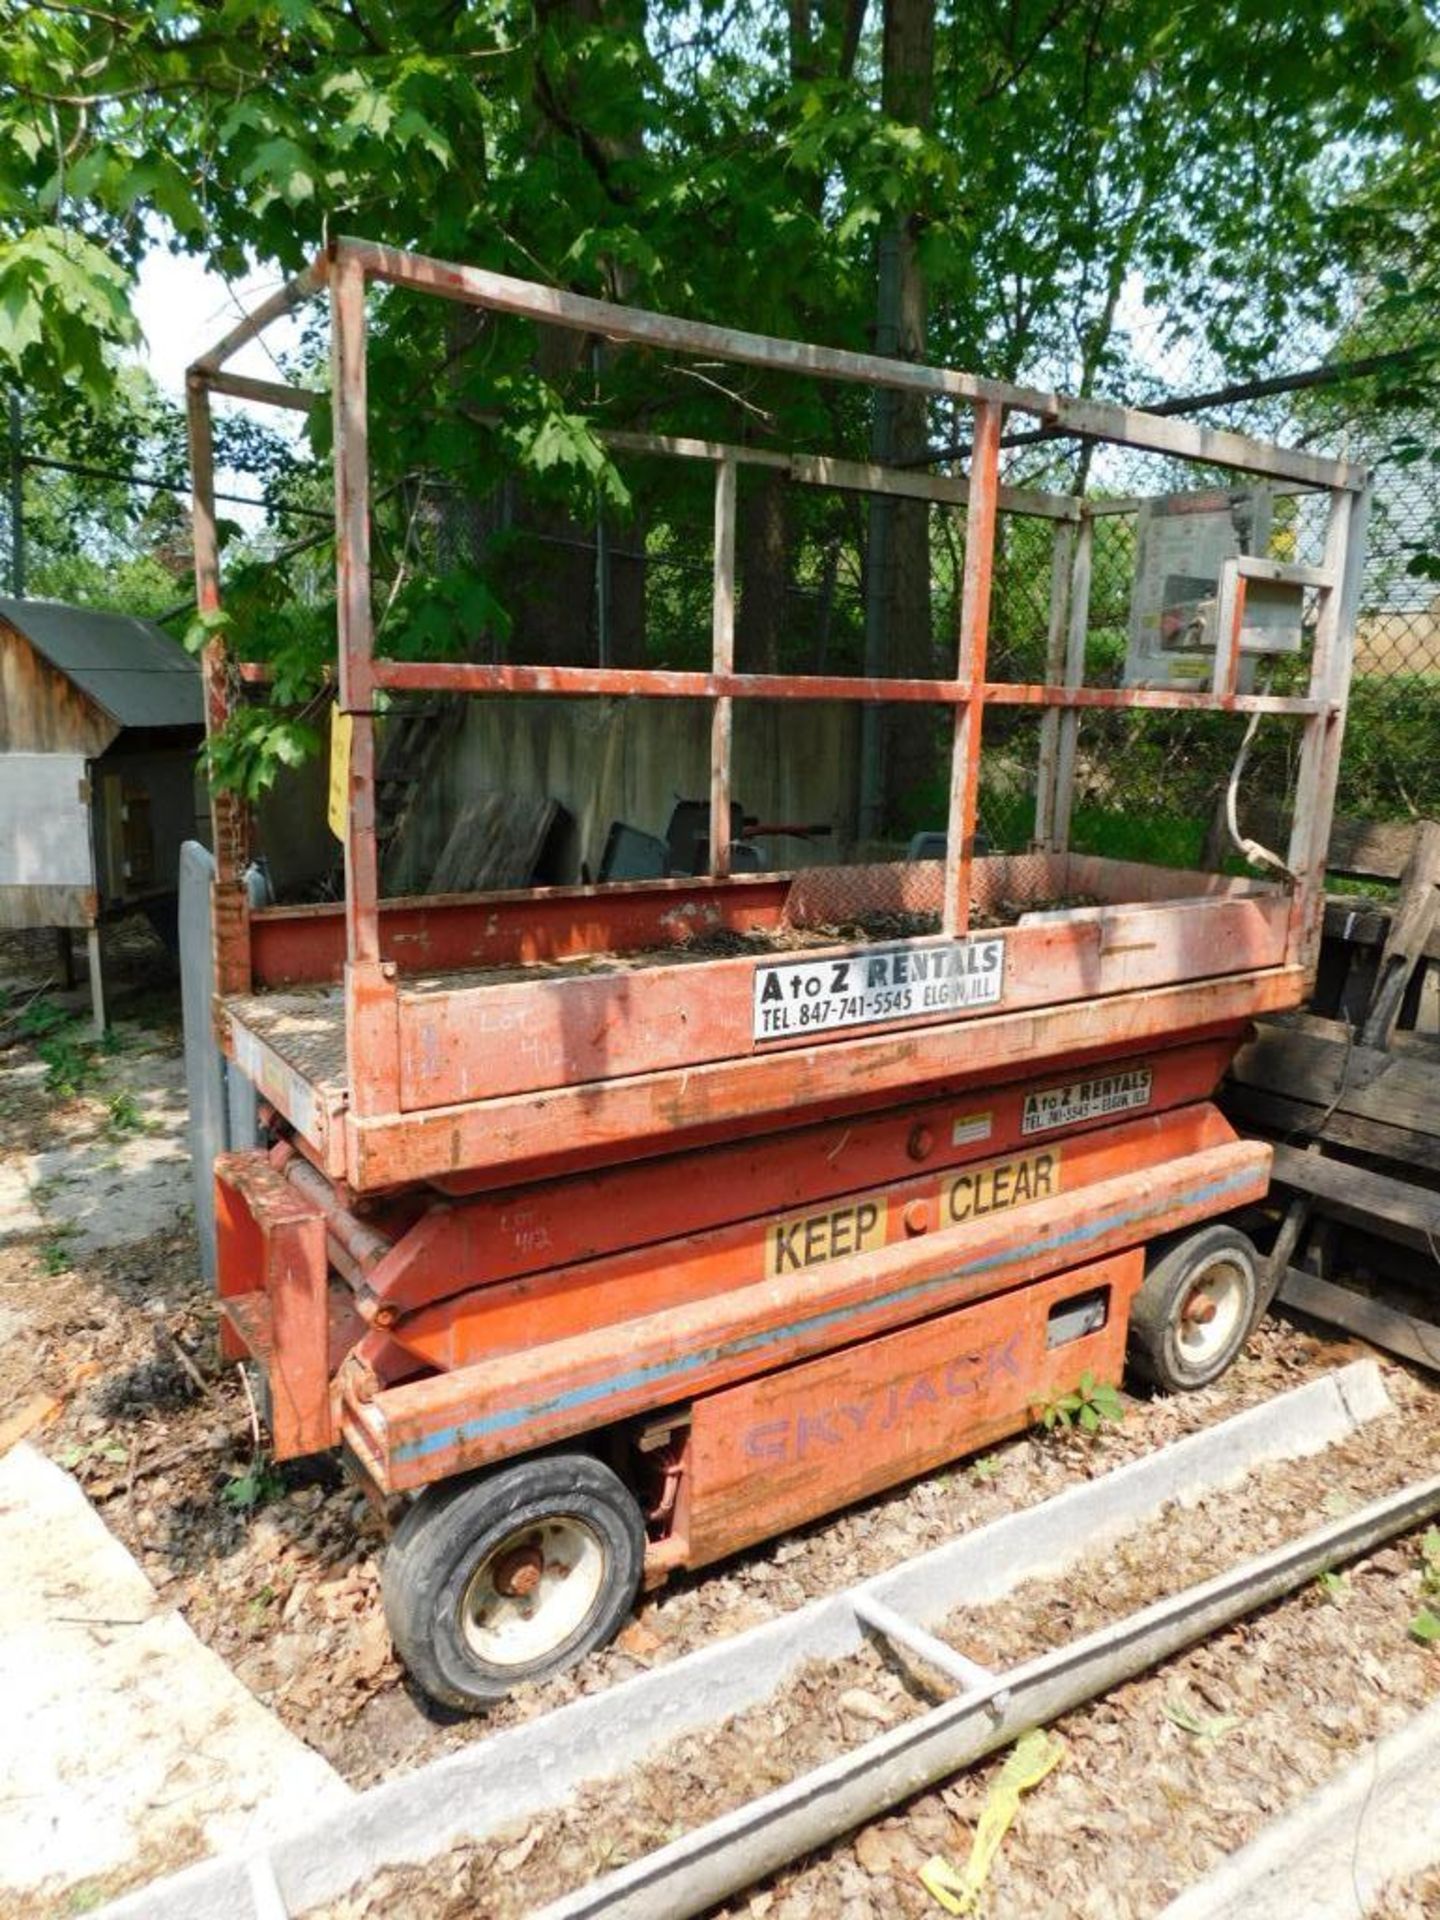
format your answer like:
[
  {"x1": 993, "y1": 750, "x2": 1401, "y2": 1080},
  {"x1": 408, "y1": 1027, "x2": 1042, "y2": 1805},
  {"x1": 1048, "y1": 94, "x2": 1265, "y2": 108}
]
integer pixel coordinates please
[{"x1": 1162, "y1": 1701, "x2": 1440, "y2": 1920}]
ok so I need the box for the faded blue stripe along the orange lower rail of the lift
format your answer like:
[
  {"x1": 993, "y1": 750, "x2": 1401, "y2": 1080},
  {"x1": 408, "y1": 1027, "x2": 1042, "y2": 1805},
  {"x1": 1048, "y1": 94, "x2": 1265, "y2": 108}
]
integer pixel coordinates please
[{"x1": 394, "y1": 1169, "x2": 1254, "y2": 1461}]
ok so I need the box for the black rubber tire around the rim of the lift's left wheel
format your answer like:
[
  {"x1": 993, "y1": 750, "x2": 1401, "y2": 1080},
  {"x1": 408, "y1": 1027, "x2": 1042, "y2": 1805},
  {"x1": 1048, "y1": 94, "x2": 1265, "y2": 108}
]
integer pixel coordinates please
[{"x1": 382, "y1": 1453, "x2": 645, "y2": 1711}]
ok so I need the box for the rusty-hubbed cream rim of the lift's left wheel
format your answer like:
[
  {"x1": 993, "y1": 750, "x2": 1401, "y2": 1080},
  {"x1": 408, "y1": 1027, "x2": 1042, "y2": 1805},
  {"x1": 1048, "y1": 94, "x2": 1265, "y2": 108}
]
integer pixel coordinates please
[{"x1": 461, "y1": 1515, "x2": 605, "y2": 1667}]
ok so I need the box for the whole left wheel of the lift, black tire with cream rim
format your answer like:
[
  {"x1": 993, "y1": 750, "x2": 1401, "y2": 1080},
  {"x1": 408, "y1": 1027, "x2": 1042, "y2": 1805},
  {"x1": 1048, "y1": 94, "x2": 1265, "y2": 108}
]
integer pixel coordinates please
[{"x1": 382, "y1": 1453, "x2": 645, "y2": 1709}]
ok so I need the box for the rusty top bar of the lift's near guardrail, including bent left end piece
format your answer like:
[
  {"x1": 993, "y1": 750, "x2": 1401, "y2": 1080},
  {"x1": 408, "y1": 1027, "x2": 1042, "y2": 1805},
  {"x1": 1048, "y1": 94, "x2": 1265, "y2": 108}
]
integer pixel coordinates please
[{"x1": 190, "y1": 238, "x2": 1367, "y2": 493}]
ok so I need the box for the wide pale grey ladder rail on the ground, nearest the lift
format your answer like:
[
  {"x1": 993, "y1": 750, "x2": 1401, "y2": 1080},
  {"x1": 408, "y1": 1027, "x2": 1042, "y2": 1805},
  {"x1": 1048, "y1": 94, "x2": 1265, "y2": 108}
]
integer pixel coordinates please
[{"x1": 102, "y1": 1359, "x2": 1392, "y2": 1920}]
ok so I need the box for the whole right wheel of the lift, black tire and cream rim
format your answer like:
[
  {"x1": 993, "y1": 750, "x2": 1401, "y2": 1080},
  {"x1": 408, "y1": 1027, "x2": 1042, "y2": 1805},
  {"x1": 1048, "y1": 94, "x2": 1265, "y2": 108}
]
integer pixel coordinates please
[{"x1": 1129, "y1": 1225, "x2": 1260, "y2": 1394}]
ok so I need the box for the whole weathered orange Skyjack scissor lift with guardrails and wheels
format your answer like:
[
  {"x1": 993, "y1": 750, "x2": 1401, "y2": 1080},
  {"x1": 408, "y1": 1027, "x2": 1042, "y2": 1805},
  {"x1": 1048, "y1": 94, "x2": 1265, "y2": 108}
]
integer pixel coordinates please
[{"x1": 190, "y1": 240, "x2": 1367, "y2": 1705}]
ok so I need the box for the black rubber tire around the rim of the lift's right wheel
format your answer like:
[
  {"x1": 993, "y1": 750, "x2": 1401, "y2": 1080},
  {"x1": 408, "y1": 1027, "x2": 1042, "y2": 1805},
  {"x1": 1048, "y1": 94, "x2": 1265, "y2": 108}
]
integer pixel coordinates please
[{"x1": 1127, "y1": 1221, "x2": 1260, "y2": 1394}]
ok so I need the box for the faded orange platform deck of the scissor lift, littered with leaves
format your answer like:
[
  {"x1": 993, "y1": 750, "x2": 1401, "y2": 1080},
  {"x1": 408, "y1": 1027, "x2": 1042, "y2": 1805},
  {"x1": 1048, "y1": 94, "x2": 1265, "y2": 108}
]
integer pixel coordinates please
[{"x1": 223, "y1": 854, "x2": 1296, "y2": 1192}]
